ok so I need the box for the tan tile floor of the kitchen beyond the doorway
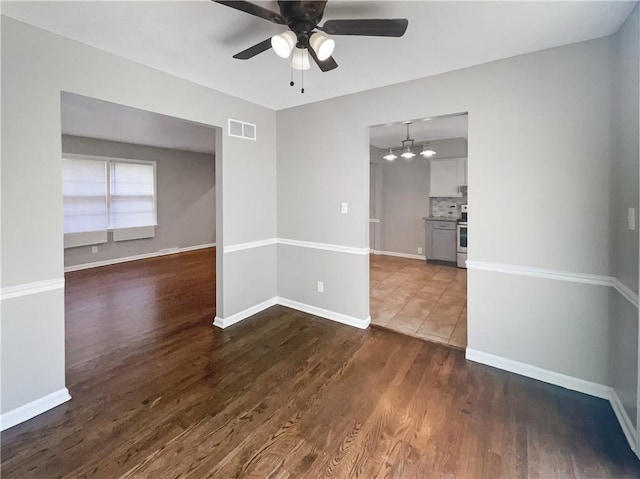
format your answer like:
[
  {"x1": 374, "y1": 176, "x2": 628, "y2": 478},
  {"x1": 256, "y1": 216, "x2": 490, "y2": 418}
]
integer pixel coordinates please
[{"x1": 370, "y1": 255, "x2": 467, "y2": 348}]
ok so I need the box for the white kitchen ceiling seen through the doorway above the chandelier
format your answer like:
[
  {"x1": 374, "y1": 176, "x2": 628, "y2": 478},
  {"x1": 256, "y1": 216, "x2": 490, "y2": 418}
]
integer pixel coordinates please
[{"x1": 369, "y1": 114, "x2": 469, "y2": 148}]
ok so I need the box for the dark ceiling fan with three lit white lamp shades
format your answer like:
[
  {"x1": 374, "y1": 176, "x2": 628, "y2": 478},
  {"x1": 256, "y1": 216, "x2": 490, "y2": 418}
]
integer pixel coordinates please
[{"x1": 214, "y1": 0, "x2": 409, "y2": 75}]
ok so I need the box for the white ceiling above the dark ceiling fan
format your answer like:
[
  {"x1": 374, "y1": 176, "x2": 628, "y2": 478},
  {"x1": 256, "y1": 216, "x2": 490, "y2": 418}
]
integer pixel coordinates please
[{"x1": 2, "y1": 0, "x2": 635, "y2": 110}]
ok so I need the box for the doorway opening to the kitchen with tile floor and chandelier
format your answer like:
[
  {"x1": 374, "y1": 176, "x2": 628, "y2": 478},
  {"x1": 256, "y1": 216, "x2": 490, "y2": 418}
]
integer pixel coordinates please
[{"x1": 369, "y1": 114, "x2": 468, "y2": 349}]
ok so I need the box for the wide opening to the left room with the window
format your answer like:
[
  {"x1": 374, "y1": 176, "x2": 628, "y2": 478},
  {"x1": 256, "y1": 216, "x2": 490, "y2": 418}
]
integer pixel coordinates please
[{"x1": 61, "y1": 92, "x2": 221, "y2": 376}]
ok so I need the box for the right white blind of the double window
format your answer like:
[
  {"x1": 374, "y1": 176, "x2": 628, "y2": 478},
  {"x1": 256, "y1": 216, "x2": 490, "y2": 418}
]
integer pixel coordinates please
[{"x1": 111, "y1": 161, "x2": 156, "y2": 229}]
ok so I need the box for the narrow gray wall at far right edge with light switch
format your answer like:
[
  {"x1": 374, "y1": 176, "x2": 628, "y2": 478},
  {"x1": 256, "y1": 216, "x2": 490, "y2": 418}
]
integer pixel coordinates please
[{"x1": 609, "y1": 5, "x2": 640, "y2": 436}]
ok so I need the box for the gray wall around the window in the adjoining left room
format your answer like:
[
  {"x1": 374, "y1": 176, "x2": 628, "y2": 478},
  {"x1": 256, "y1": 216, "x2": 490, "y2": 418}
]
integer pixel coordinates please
[{"x1": 62, "y1": 136, "x2": 216, "y2": 266}]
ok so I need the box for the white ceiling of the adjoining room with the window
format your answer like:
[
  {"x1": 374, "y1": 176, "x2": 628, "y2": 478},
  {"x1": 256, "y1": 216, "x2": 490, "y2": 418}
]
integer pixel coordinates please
[{"x1": 61, "y1": 89, "x2": 215, "y2": 154}]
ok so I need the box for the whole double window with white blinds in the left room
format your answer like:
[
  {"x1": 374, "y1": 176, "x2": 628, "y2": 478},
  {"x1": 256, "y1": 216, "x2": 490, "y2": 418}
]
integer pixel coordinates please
[{"x1": 62, "y1": 155, "x2": 156, "y2": 248}]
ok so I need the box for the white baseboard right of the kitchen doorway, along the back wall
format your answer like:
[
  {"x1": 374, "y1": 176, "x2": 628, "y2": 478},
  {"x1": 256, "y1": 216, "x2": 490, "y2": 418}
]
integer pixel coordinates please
[{"x1": 466, "y1": 348, "x2": 611, "y2": 399}]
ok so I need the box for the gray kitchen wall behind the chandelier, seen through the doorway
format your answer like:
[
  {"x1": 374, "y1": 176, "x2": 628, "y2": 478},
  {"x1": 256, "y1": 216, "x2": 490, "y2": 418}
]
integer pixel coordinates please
[{"x1": 370, "y1": 138, "x2": 467, "y2": 255}]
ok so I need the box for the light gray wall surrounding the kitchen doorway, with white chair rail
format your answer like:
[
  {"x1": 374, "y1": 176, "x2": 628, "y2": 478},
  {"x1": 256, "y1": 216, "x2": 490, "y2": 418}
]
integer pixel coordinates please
[{"x1": 277, "y1": 37, "x2": 615, "y2": 384}]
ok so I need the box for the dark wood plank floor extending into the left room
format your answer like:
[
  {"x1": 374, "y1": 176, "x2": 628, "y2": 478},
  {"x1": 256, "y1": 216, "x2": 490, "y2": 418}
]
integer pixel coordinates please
[{"x1": 2, "y1": 251, "x2": 640, "y2": 479}]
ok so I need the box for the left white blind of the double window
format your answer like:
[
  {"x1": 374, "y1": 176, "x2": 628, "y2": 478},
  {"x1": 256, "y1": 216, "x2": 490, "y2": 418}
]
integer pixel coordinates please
[{"x1": 62, "y1": 158, "x2": 108, "y2": 234}]
